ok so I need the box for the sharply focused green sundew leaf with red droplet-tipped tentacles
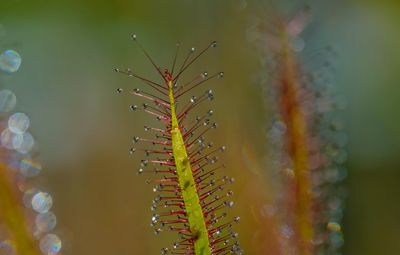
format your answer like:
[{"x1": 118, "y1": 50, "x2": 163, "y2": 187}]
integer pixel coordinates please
[{"x1": 115, "y1": 35, "x2": 242, "y2": 255}]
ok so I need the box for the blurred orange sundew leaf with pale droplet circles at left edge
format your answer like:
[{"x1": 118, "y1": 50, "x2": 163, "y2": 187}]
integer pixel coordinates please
[{"x1": 0, "y1": 31, "x2": 61, "y2": 255}]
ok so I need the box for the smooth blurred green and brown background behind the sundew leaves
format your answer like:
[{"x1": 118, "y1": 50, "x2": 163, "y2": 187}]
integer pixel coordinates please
[{"x1": 0, "y1": 0, "x2": 400, "y2": 255}]
